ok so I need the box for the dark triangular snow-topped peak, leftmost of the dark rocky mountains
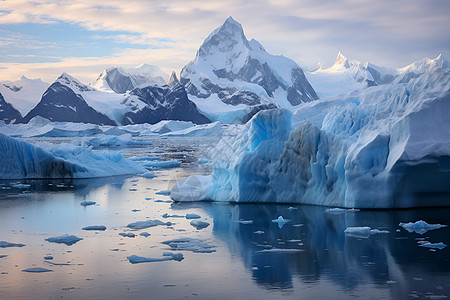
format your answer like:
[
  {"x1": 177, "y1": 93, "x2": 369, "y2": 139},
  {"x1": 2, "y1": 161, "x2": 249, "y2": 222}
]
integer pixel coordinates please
[{"x1": 23, "y1": 73, "x2": 116, "y2": 125}]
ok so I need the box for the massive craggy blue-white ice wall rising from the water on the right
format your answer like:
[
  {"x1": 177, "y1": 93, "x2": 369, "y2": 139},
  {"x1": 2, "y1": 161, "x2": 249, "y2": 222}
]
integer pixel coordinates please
[{"x1": 171, "y1": 71, "x2": 450, "y2": 208}]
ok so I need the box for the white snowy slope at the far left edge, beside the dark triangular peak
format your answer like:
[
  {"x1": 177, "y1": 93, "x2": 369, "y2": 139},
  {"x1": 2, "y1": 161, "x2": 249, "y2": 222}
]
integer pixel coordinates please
[{"x1": 0, "y1": 76, "x2": 50, "y2": 116}]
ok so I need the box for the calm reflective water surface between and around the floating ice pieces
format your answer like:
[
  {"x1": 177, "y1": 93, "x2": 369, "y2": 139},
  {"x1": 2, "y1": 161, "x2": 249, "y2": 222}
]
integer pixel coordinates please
[{"x1": 0, "y1": 138, "x2": 450, "y2": 299}]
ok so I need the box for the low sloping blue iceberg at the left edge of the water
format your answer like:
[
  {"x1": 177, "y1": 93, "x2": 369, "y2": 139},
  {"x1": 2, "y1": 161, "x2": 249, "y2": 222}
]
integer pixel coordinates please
[{"x1": 0, "y1": 133, "x2": 146, "y2": 179}]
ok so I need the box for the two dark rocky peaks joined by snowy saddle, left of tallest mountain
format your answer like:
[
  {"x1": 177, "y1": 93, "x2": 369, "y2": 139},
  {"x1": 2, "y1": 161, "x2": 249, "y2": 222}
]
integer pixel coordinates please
[{"x1": 22, "y1": 73, "x2": 210, "y2": 125}]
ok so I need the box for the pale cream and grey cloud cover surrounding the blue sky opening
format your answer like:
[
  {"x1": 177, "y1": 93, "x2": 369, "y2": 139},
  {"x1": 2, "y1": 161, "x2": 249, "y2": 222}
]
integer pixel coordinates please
[{"x1": 0, "y1": 0, "x2": 450, "y2": 77}]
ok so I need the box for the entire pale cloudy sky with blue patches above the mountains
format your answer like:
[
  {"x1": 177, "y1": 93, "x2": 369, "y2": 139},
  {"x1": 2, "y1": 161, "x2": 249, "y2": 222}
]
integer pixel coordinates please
[{"x1": 0, "y1": 0, "x2": 450, "y2": 83}]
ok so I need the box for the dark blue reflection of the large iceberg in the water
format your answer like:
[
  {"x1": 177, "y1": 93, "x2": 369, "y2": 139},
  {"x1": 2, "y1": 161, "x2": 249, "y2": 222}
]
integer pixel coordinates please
[{"x1": 172, "y1": 203, "x2": 450, "y2": 299}]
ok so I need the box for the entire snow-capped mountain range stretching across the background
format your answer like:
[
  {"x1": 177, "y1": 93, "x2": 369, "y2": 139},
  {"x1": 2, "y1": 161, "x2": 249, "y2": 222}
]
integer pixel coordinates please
[{"x1": 0, "y1": 17, "x2": 449, "y2": 125}]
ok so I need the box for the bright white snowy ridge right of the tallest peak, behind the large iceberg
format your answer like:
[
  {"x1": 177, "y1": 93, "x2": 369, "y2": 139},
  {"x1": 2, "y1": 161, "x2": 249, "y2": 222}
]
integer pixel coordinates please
[{"x1": 306, "y1": 52, "x2": 449, "y2": 98}]
